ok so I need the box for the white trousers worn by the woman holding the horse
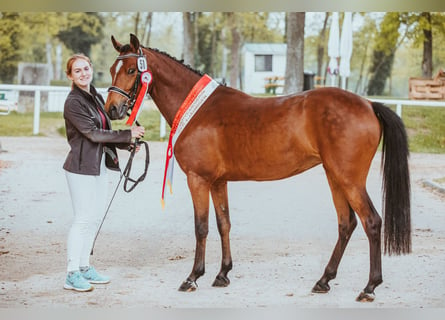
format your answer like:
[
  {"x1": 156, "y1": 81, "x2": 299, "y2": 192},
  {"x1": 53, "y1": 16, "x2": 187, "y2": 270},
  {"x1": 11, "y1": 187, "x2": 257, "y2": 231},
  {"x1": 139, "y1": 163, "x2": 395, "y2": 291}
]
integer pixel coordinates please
[{"x1": 65, "y1": 155, "x2": 108, "y2": 272}]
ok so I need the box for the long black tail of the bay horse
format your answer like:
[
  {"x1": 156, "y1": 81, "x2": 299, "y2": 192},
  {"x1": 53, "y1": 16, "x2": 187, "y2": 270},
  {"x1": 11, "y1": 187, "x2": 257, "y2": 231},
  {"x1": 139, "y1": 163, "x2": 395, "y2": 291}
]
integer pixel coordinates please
[{"x1": 372, "y1": 102, "x2": 411, "y2": 255}]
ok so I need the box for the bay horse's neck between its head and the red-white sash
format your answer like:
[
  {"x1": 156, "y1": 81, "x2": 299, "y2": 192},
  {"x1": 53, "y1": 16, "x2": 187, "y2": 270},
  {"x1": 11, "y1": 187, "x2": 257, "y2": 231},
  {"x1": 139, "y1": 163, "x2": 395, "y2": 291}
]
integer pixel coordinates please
[{"x1": 148, "y1": 51, "x2": 200, "y2": 126}]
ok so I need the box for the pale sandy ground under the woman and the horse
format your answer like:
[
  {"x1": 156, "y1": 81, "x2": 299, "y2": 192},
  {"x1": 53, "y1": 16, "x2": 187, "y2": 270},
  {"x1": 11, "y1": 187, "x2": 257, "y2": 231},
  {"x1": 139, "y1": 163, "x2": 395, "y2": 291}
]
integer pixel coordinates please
[{"x1": 0, "y1": 137, "x2": 445, "y2": 308}]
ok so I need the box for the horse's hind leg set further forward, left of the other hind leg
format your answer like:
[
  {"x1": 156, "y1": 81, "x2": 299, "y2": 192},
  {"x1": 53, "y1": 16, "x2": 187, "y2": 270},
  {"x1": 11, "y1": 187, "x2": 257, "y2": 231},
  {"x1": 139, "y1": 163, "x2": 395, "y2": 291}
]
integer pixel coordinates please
[{"x1": 312, "y1": 176, "x2": 357, "y2": 293}]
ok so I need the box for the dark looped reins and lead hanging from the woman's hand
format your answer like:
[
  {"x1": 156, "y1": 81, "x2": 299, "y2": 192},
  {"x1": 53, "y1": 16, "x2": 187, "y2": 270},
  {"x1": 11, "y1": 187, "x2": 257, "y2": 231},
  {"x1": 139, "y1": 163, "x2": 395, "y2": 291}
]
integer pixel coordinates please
[{"x1": 90, "y1": 120, "x2": 150, "y2": 255}]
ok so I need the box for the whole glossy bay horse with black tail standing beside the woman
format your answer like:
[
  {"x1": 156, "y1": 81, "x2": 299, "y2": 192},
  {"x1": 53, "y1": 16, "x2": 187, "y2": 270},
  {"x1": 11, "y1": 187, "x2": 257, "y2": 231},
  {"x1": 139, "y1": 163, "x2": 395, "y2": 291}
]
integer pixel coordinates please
[{"x1": 105, "y1": 34, "x2": 411, "y2": 301}]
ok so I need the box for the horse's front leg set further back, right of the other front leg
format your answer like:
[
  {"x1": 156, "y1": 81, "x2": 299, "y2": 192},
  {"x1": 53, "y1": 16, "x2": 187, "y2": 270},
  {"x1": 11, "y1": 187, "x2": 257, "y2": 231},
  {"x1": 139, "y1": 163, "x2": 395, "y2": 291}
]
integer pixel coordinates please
[{"x1": 210, "y1": 181, "x2": 232, "y2": 287}]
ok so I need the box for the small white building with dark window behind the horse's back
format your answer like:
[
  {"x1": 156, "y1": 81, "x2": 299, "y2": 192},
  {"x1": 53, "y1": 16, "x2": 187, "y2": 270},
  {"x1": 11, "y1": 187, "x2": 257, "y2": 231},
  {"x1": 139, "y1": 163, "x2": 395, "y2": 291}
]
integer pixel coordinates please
[{"x1": 242, "y1": 43, "x2": 287, "y2": 94}]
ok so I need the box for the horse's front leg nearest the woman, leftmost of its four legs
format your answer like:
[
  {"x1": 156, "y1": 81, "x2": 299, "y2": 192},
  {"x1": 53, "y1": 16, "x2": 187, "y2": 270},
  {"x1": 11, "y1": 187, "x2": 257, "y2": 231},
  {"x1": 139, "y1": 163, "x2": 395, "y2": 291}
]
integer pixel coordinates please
[{"x1": 178, "y1": 173, "x2": 210, "y2": 291}]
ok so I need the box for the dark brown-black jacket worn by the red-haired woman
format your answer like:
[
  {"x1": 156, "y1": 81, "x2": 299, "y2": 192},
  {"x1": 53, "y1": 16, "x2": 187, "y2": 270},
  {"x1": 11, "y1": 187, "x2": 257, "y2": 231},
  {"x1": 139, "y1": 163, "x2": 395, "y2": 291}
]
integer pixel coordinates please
[{"x1": 63, "y1": 85, "x2": 131, "y2": 175}]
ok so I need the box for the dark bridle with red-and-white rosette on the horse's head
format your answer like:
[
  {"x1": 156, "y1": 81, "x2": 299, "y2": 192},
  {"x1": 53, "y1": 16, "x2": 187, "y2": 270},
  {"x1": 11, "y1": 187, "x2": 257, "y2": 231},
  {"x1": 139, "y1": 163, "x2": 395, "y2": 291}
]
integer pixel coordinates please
[{"x1": 108, "y1": 48, "x2": 153, "y2": 125}]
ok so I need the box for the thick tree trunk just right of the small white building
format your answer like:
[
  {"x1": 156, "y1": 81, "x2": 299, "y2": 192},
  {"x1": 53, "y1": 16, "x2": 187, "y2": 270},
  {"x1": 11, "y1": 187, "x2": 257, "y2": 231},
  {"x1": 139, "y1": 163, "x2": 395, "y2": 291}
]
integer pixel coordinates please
[{"x1": 283, "y1": 12, "x2": 305, "y2": 94}]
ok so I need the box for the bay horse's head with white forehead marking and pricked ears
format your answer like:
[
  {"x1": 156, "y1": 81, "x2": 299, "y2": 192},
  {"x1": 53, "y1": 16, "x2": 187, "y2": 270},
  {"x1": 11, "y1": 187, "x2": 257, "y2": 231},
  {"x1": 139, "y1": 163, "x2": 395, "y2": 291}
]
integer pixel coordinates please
[{"x1": 105, "y1": 34, "x2": 151, "y2": 120}]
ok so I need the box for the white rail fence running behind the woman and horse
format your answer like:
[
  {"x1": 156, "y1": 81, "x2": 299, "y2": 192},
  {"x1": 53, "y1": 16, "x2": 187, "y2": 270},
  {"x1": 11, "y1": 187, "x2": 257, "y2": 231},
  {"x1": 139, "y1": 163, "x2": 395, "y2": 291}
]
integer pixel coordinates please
[{"x1": 0, "y1": 84, "x2": 445, "y2": 138}]
